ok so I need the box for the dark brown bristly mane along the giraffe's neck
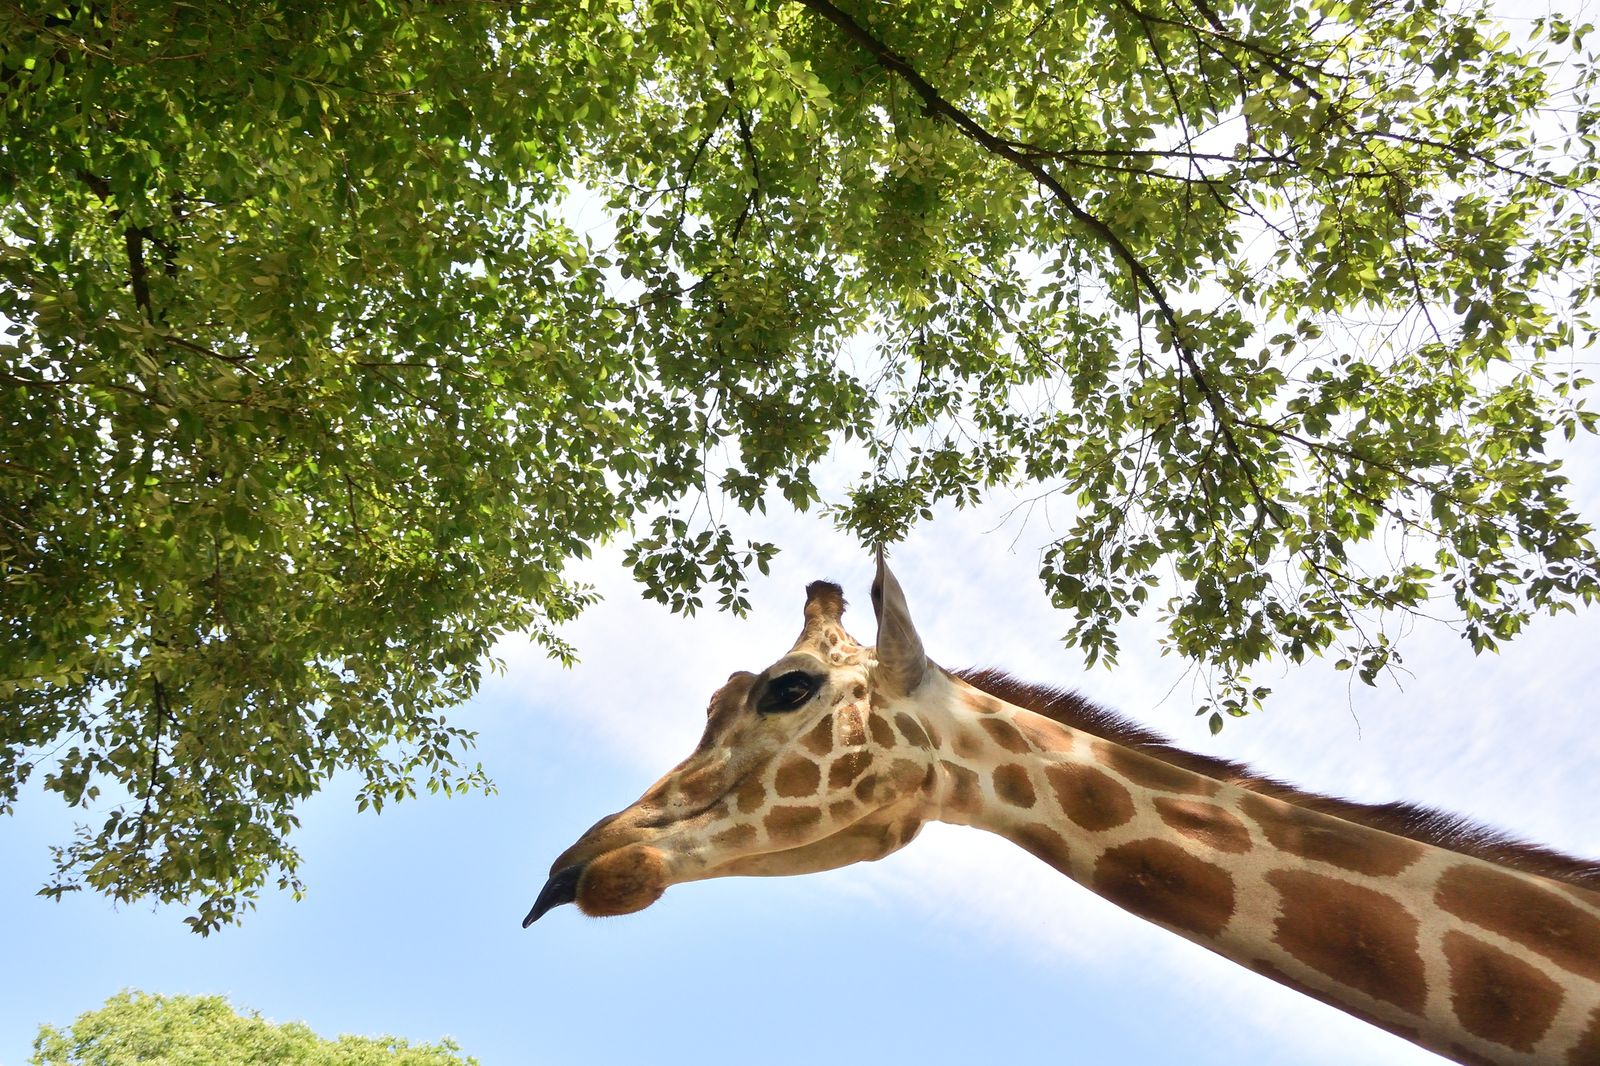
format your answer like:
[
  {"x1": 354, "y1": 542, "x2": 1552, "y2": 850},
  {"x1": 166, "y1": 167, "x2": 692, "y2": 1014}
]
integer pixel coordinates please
[{"x1": 955, "y1": 669, "x2": 1600, "y2": 890}]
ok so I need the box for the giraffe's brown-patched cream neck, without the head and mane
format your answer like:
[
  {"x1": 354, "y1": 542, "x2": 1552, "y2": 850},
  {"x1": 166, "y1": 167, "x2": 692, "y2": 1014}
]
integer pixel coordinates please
[{"x1": 914, "y1": 671, "x2": 1600, "y2": 1066}]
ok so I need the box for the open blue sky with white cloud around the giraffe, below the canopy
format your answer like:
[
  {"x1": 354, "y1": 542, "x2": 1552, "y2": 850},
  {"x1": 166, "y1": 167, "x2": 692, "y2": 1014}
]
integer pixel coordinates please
[{"x1": 0, "y1": 435, "x2": 1600, "y2": 1066}]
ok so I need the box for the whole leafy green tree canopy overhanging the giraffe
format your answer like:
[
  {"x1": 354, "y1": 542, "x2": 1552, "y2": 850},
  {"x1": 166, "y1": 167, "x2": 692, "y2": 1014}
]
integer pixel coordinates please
[{"x1": 0, "y1": 0, "x2": 1600, "y2": 932}]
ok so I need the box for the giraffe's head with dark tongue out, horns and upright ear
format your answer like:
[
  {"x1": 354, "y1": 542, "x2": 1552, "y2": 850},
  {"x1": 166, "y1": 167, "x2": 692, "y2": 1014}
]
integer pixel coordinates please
[{"x1": 523, "y1": 555, "x2": 939, "y2": 925}]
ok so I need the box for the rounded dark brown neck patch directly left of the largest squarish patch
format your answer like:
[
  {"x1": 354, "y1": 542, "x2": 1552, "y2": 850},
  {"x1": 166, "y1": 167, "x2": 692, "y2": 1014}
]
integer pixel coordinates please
[{"x1": 1094, "y1": 840, "x2": 1234, "y2": 936}]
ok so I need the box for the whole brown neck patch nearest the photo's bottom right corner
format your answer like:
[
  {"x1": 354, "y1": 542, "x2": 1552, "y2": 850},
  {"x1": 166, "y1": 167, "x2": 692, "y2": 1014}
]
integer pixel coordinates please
[{"x1": 1443, "y1": 930, "x2": 1563, "y2": 1052}]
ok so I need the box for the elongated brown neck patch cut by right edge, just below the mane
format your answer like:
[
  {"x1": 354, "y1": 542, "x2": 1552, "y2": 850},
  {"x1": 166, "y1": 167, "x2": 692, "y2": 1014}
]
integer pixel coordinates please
[{"x1": 1434, "y1": 863, "x2": 1600, "y2": 981}]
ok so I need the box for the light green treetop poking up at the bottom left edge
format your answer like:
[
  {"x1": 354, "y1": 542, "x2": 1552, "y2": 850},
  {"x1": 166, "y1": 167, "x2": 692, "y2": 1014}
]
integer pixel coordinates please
[{"x1": 29, "y1": 992, "x2": 477, "y2": 1066}]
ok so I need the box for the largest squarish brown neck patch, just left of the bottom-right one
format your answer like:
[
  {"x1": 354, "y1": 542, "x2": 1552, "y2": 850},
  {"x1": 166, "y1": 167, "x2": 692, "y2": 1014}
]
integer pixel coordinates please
[{"x1": 1267, "y1": 869, "x2": 1427, "y2": 1015}]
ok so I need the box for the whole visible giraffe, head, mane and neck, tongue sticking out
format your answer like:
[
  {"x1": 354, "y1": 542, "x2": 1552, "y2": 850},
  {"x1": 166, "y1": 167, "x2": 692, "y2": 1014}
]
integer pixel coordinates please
[{"x1": 523, "y1": 554, "x2": 1600, "y2": 1066}]
